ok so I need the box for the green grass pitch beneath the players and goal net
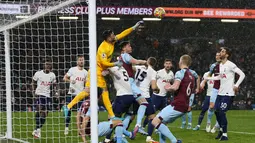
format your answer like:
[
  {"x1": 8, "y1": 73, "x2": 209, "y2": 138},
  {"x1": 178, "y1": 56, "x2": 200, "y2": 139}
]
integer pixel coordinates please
[{"x1": 0, "y1": 110, "x2": 255, "y2": 143}]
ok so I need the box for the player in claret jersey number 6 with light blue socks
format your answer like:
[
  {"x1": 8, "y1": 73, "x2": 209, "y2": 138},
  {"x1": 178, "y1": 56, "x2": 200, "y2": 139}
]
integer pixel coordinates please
[{"x1": 152, "y1": 55, "x2": 195, "y2": 143}]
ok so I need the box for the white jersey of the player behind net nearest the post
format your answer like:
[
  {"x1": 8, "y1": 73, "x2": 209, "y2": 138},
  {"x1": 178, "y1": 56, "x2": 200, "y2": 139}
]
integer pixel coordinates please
[{"x1": 66, "y1": 66, "x2": 88, "y2": 95}]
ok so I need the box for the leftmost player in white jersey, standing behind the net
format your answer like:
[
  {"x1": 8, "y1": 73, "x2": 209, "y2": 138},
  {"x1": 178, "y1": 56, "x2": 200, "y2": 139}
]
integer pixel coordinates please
[{"x1": 32, "y1": 62, "x2": 58, "y2": 138}]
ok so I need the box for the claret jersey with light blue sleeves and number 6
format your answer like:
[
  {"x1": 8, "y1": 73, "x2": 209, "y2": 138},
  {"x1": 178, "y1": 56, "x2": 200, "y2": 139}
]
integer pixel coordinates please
[{"x1": 171, "y1": 69, "x2": 195, "y2": 113}]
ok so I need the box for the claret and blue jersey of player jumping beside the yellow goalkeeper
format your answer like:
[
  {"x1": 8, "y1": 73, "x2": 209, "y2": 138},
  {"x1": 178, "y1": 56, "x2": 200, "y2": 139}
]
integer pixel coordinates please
[{"x1": 120, "y1": 53, "x2": 134, "y2": 78}]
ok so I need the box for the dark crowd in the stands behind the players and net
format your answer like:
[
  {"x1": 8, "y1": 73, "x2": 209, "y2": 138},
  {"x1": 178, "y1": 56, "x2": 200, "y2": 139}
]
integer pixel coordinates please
[{"x1": 0, "y1": 21, "x2": 255, "y2": 110}]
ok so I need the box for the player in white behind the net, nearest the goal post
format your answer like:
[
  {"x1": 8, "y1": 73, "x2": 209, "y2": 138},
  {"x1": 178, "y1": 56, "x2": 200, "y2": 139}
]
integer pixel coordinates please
[{"x1": 63, "y1": 55, "x2": 88, "y2": 135}]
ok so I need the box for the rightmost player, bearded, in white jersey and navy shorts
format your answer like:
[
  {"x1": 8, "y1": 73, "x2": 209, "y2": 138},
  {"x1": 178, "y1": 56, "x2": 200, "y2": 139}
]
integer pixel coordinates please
[{"x1": 215, "y1": 47, "x2": 245, "y2": 141}]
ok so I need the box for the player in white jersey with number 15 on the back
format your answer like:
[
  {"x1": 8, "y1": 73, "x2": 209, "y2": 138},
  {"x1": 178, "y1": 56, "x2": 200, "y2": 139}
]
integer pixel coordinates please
[{"x1": 135, "y1": 57, "x2": 159, "y2": 143}]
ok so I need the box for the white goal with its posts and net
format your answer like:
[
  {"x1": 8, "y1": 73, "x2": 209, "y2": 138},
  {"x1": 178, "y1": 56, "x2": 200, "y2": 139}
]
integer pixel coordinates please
[{"x1": 0, "y1": 0, "x2": 98, "y2": 143}]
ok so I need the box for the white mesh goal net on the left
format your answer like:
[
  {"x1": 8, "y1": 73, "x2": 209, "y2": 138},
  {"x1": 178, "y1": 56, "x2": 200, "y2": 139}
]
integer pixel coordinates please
[{"x1": 0, "y1": 0, "x2": 97, "y2": 143}]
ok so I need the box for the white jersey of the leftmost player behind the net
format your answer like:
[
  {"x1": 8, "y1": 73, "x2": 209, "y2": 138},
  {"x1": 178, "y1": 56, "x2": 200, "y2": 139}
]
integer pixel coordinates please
[{"x1": 33, "y1": 70, "x2": 56, "y2": 97}]
